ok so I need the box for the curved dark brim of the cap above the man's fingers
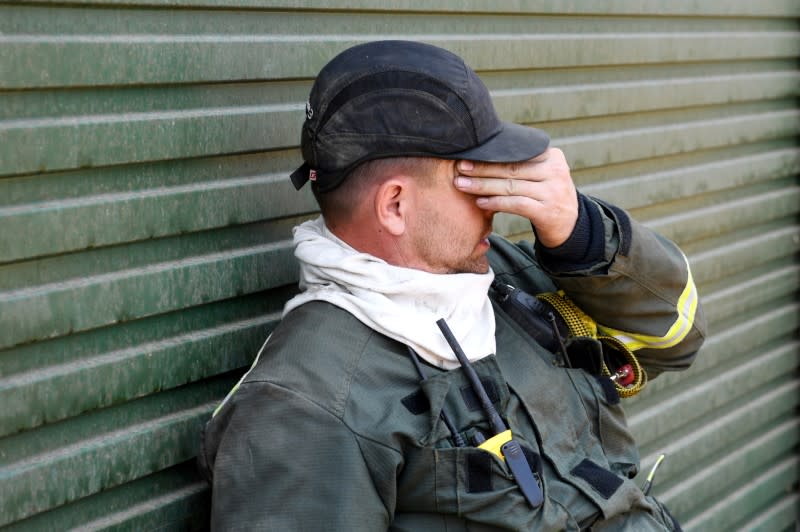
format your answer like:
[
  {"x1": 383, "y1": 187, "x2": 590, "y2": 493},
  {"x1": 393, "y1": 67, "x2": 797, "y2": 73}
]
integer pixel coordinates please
[{"x1": 448, "y1": 122, "x2": 550, "y2": 163}]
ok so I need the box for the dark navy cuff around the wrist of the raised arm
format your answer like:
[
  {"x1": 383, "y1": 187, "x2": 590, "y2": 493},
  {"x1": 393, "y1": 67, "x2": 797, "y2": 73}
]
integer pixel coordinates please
[{"x1": 534, "y1": 192, "x2": 605, "y2": 273}]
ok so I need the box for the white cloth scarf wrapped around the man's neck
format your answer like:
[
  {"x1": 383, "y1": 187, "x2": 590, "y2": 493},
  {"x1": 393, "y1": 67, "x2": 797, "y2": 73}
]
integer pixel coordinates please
[{"x1": 283, "y1": 217, "x2": 495, "y2": 369}]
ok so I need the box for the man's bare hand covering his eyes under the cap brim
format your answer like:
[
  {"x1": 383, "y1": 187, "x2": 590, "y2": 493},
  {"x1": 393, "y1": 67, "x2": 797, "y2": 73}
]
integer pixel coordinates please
[{"x1": 454, "y1": 148, "x2": 578, "y2": 248}]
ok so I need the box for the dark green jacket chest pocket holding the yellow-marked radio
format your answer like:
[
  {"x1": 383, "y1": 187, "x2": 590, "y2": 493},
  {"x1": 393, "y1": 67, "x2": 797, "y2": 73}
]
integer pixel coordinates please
[{"x1": 396, "y1": 356, "x2": 576, "y2": 530}]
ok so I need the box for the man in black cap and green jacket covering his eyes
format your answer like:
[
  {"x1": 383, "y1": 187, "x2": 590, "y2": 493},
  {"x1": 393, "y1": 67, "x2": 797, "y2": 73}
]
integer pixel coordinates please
[{"x1": 200, "y1": 41, "x2": 704, "y2": 531}]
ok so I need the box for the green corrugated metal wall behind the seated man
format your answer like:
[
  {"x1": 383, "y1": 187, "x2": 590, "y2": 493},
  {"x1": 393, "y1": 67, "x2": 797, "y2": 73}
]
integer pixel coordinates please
[{"x1": 0, "y1": 0, "x2": 800, "y2": 531}]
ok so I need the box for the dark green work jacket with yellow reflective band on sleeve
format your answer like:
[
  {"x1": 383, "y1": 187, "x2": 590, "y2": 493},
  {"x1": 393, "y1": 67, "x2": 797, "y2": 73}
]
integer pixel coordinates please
[{"x1": 200, "y1": 200, "x2": 703, "y2": 531}]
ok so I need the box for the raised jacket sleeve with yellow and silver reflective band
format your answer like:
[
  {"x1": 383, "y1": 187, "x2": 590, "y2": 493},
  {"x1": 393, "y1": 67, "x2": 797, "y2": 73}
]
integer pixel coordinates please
[{"x1": 536, "y1": 196, "x2": 706, "y2": 378}]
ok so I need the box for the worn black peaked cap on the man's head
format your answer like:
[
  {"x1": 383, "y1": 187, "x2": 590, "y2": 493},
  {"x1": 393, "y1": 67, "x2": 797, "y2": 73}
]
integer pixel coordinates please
[{"x1": 292, "y1": 41, "x2": 550, "y2": 192}]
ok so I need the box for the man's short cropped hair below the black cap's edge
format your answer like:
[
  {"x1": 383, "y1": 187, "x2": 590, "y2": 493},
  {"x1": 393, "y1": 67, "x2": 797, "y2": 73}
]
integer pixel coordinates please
[{"x1": 311, "y1": 157, "x2": 444, "y2": 222}]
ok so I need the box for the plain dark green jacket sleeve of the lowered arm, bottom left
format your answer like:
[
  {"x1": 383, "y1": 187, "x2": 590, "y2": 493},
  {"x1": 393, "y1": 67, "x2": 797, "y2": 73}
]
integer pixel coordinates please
[{"x1": 200, "y1": 382, "x2": 390, "y2": 531}]
